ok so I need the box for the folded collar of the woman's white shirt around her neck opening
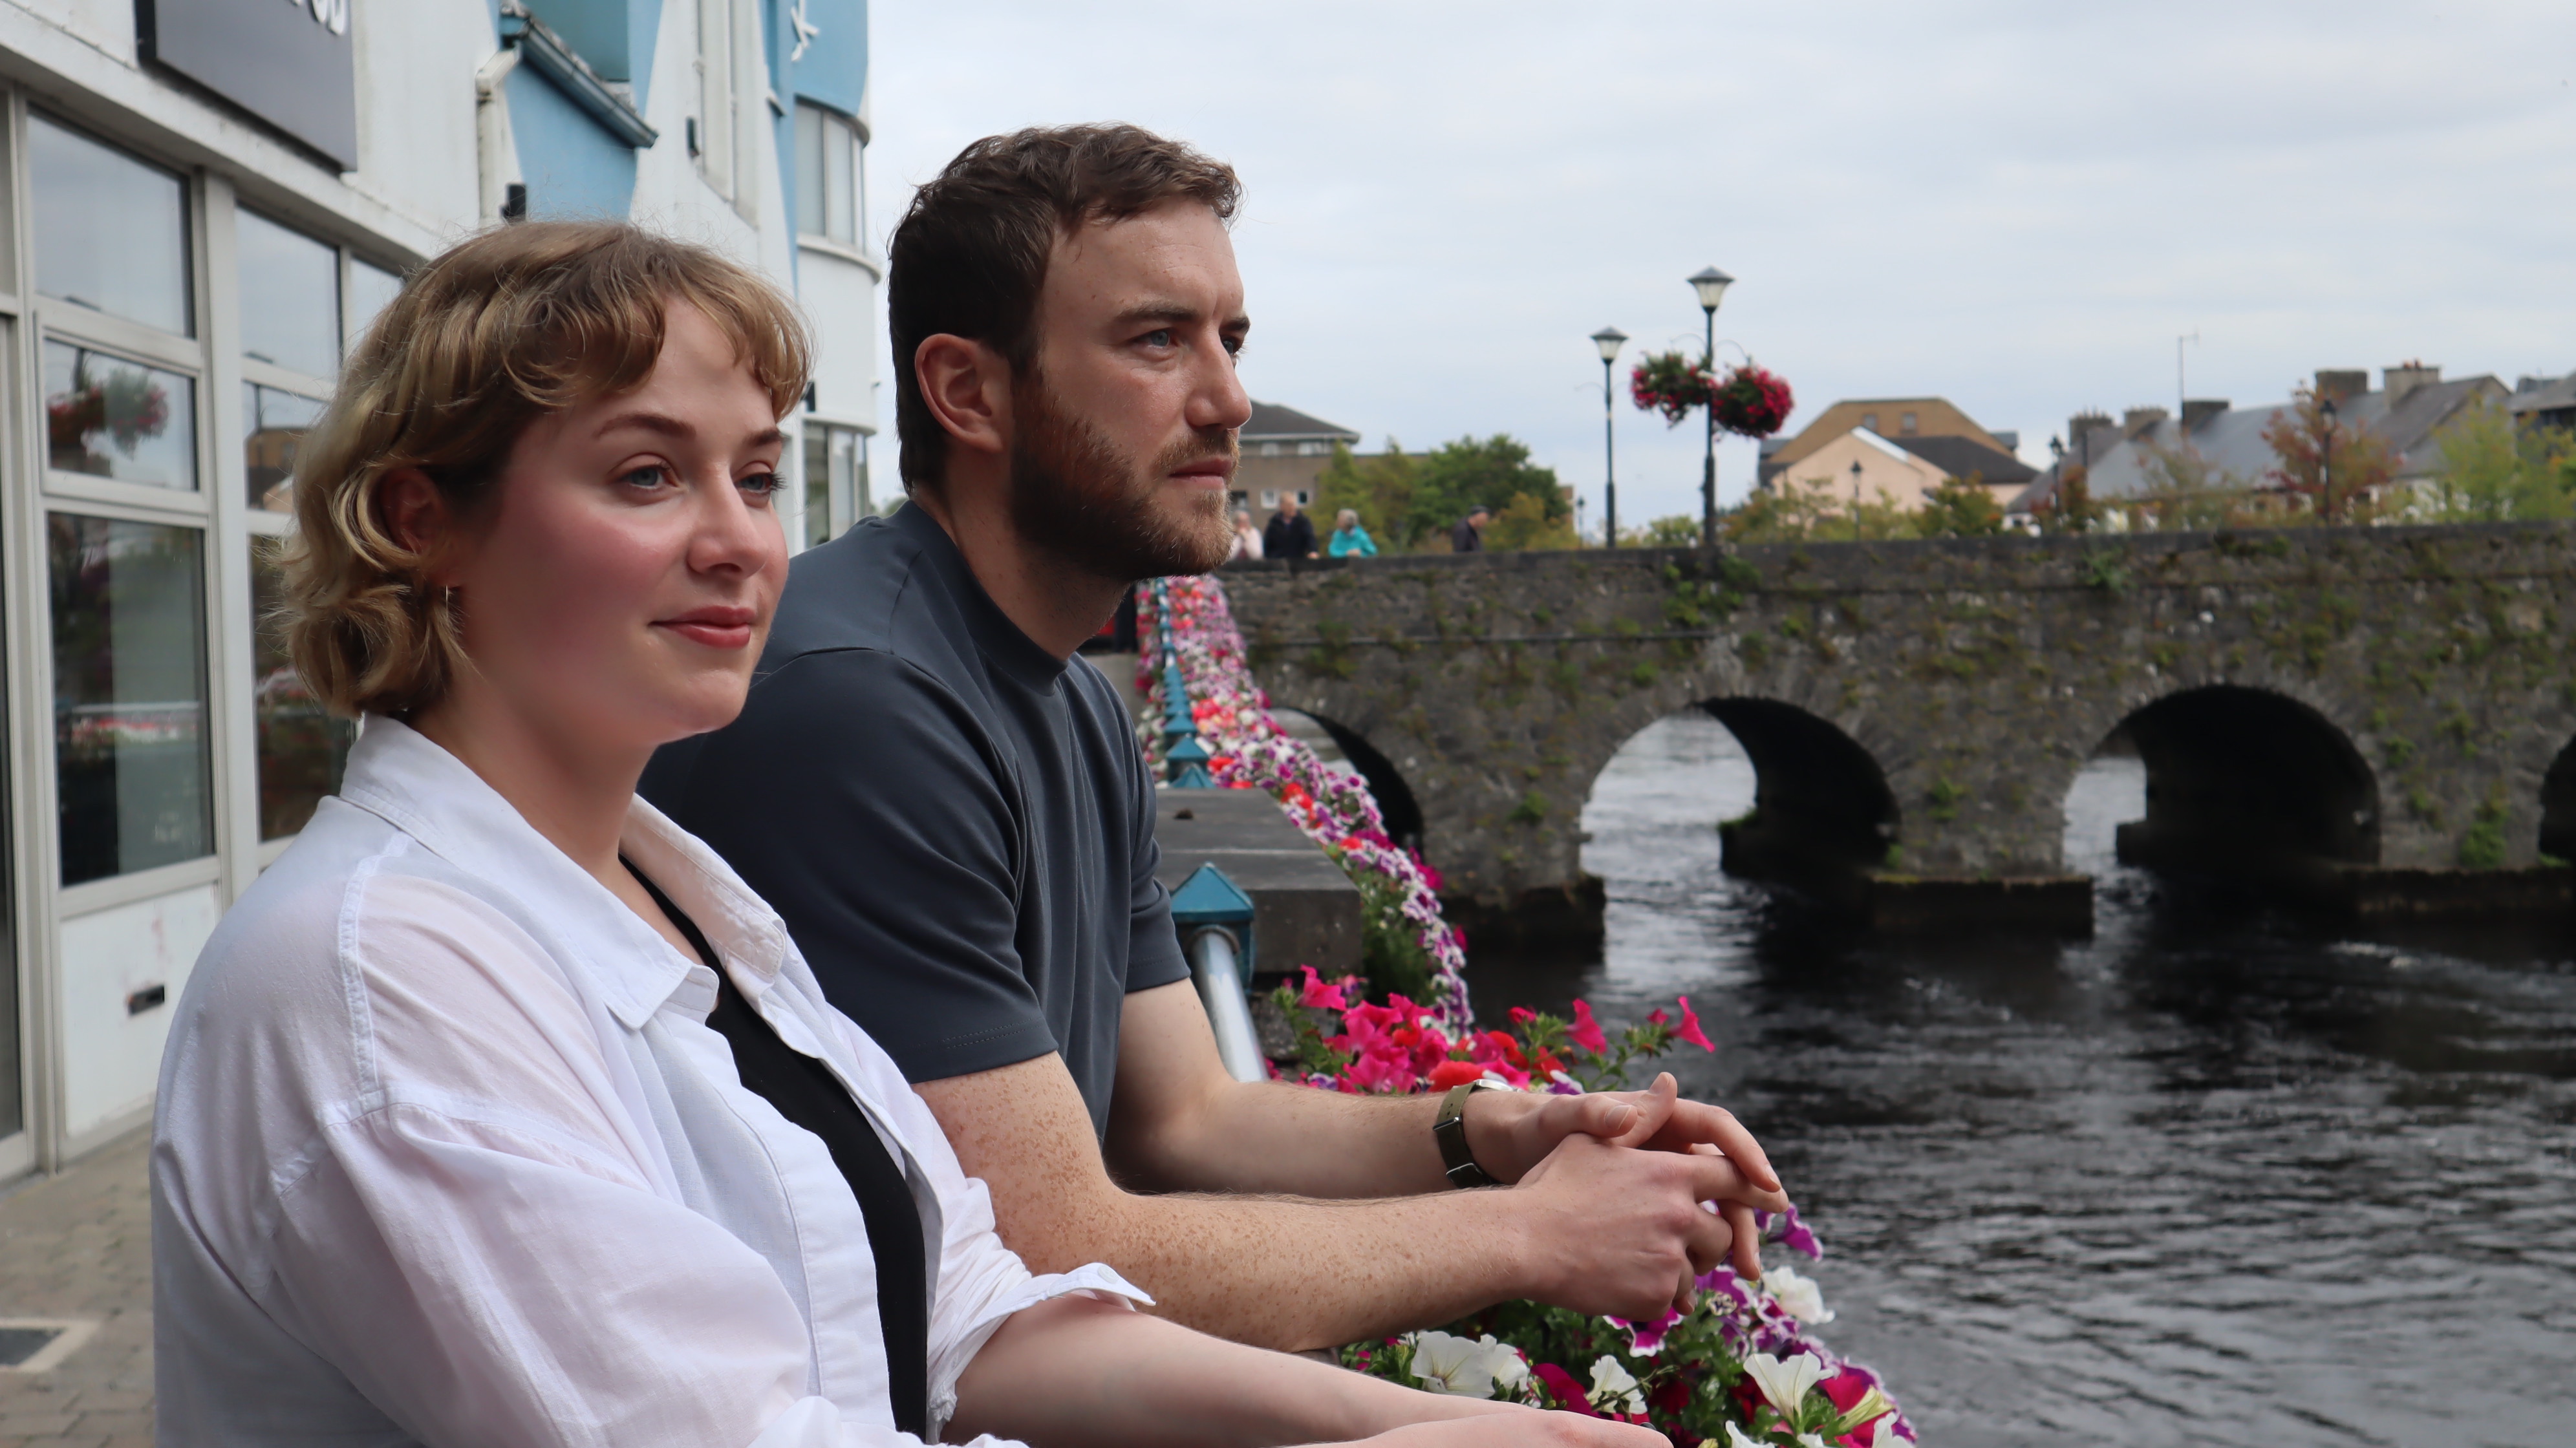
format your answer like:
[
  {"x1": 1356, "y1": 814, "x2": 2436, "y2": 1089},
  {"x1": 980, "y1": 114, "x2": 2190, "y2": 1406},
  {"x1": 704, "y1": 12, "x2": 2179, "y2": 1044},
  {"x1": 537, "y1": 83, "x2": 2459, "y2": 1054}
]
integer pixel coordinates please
[{"x1": 340, "y1": 714, "x2": 788, "y2": 1030}]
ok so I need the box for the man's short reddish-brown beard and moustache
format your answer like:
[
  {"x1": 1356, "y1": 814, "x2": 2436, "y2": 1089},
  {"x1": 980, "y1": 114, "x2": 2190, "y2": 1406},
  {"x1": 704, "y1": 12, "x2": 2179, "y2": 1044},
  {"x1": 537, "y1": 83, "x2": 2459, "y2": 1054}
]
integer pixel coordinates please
[{"x1": 1010, "y1": 371, "x2": 1234, "y2": 582}]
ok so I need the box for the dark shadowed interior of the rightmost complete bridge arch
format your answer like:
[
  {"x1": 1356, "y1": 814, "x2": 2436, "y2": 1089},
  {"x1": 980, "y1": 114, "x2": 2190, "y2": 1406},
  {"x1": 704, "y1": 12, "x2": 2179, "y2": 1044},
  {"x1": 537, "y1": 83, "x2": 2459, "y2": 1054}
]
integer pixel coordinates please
[{"x1": 2118, "y1": 683, "x2": 2380, "y2": 873}]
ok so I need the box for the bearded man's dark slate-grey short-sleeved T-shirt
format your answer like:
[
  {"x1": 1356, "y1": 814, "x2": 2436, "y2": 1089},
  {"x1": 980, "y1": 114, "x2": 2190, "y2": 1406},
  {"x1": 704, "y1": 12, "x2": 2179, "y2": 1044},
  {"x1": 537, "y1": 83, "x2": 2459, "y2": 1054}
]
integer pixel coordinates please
[{"x1": 641, "y1": 507, "x2": 1190, "y2": 1131}]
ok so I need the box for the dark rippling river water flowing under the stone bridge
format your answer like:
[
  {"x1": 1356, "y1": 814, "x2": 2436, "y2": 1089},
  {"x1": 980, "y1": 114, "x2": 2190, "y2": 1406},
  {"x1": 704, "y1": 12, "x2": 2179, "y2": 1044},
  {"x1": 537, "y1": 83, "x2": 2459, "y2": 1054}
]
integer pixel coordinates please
[{"x1": 1471, "y1": 716, "x2": 2576, "y2": 1448}]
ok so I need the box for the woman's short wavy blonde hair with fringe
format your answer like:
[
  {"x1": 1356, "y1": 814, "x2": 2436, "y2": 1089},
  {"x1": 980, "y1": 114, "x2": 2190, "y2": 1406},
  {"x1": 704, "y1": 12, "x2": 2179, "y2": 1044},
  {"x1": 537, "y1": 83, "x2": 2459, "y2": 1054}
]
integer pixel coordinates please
[{"x1": 283, "y1": 222, "x2": 814, "y2": 716}]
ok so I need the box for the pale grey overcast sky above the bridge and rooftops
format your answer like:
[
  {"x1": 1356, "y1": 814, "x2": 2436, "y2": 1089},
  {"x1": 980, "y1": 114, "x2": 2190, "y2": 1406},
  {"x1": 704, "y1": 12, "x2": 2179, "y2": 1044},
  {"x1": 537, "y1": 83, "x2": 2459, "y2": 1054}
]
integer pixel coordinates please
[{"x1": 868, "y1": 0, "x2": 2576, "y2": 526}]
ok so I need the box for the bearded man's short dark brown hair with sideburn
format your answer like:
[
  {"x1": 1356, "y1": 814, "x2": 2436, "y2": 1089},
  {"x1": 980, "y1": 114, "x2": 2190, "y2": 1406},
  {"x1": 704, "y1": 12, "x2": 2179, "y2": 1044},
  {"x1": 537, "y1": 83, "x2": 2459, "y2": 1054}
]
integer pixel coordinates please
[{"x1": 886, "y1": 123, "x2": 1244, "y2": 492}]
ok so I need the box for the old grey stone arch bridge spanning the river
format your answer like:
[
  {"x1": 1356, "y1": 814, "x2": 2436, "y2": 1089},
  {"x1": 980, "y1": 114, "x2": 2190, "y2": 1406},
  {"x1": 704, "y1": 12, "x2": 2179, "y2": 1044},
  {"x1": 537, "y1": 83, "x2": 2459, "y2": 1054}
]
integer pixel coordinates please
[{"x1": 1223, "y1": 526, "x2": 2576, "y2": 928}]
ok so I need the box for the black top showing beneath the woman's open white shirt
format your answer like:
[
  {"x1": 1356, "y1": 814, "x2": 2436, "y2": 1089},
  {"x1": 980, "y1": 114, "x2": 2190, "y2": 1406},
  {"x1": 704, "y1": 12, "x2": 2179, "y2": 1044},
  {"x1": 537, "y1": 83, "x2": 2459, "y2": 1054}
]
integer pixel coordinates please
[{"x1": 626, "y1": 863, "x2": 930, "y2": 1438}]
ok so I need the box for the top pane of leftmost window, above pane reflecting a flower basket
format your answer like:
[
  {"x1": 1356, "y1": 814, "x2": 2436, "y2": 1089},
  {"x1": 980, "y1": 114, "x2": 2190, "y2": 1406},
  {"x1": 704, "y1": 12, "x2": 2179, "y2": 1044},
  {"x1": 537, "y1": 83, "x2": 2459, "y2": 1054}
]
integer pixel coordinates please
[{"x1": 26, "y1": 116, "x2": 196, "y2": 337}]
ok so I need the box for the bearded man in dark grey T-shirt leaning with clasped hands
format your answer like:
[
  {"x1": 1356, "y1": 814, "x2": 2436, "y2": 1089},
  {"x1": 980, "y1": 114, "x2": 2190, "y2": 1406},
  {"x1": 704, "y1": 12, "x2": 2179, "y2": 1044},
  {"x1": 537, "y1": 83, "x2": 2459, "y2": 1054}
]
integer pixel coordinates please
[{"x1": 644, "y1": 126, "x2": 1785, "y2": 1348}]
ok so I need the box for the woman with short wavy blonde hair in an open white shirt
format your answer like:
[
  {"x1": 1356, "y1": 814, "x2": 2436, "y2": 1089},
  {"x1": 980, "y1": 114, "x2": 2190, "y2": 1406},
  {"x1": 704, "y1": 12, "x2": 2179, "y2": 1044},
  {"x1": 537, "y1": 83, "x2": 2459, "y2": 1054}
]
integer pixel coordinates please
[{"x1": 152, "y1": 222, "x2": 1657, "y2": 1448}]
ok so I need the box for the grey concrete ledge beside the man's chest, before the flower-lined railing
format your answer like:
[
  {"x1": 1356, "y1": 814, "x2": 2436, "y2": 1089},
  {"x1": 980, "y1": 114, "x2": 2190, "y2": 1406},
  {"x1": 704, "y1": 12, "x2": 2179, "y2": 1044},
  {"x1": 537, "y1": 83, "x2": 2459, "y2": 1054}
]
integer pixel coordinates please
[{"x1": 1154, "y1": 789, "x2": 1360, "y2": 979}]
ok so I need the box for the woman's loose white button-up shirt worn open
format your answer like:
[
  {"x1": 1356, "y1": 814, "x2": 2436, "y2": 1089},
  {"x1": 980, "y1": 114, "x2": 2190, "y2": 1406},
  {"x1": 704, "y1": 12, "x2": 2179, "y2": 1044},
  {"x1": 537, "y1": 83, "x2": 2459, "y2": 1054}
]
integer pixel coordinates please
[{"x1": 152, "y1": 719, "x2": 1144, "y2": 1448}]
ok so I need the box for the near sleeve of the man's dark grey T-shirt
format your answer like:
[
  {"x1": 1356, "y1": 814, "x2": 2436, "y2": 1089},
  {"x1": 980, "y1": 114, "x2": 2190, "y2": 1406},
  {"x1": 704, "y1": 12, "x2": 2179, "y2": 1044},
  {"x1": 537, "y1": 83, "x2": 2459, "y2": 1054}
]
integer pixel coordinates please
[{"x1": 644, "y1": 649, "x2": 1061, "y2": 1082}]
